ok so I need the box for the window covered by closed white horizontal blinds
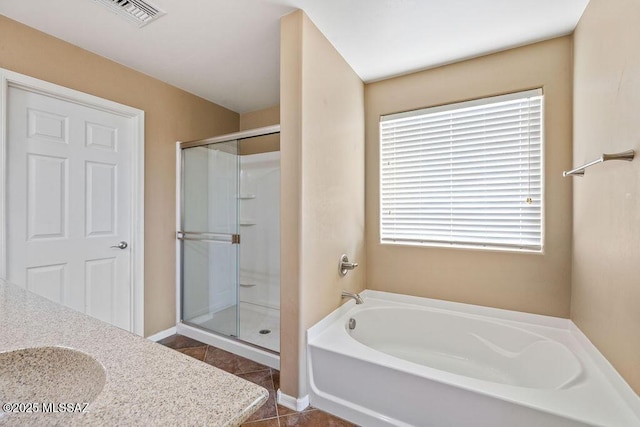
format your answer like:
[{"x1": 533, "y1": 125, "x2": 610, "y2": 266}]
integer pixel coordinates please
[{"x1": 380, "y1": 89, "x2": 543, "y2": 251}]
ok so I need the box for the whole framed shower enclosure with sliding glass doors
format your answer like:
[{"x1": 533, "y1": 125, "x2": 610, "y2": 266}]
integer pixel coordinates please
[{"x1": 177, "y1": 126, "x2": 280, "y2": 367}]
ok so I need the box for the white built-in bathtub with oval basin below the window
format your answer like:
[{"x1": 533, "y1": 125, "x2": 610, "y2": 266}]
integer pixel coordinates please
[{"x1": 307, "y1": 290, "x2": 640, "y2": 427}]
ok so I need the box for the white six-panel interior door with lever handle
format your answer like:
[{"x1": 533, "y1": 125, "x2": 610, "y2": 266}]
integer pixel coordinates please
[{"x1": 6, "y1": 87, "x2": 135, "y2": 330}]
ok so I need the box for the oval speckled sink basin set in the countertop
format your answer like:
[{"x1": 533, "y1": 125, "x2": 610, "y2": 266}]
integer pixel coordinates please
[{"x1": 0, "y1": 347, "x2": 106, "y2": 403}]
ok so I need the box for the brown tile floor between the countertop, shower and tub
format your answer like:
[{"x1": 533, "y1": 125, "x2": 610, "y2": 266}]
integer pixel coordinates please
[{"x1": 158, "y1": 335, "x2": 355, "y2": 427}]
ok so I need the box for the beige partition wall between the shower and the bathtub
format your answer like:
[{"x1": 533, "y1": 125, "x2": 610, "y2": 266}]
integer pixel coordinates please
[{"x1": 280, "y1": 11, "x2": 366, "y2": 397}]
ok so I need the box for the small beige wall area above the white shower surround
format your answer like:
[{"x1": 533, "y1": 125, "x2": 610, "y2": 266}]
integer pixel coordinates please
[{"x1": 240, "y1": 105, "x2": 280, "y2": 155}]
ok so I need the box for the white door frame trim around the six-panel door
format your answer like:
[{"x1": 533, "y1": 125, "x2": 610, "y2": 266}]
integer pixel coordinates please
[{"x1": 0, "y1": 68, "x2": 144, "y2": 336}]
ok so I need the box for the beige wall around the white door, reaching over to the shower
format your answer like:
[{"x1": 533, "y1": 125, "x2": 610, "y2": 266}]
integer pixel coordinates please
[{"x1": 0, "y1": 15, "x2": 239, "y2": 336}]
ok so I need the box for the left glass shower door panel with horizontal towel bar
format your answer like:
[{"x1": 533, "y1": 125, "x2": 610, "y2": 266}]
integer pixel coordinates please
[{"x1": 178, "y1": 141, "x2": 240, "y2": 337}]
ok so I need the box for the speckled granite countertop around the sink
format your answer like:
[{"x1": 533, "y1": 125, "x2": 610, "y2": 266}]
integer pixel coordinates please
[{"x1": 0, "y1": 280, "x2": 268, "y2": 426}]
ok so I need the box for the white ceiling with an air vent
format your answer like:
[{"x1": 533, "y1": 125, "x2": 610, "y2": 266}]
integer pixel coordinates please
[{"x1": 0, "y1": 0, "x2": 589, "y2": 113}]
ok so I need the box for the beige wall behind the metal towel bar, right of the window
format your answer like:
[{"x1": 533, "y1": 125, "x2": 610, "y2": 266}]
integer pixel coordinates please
[{"x1": 571, "y1": 0, "x2": 640, "y2": 393}]
